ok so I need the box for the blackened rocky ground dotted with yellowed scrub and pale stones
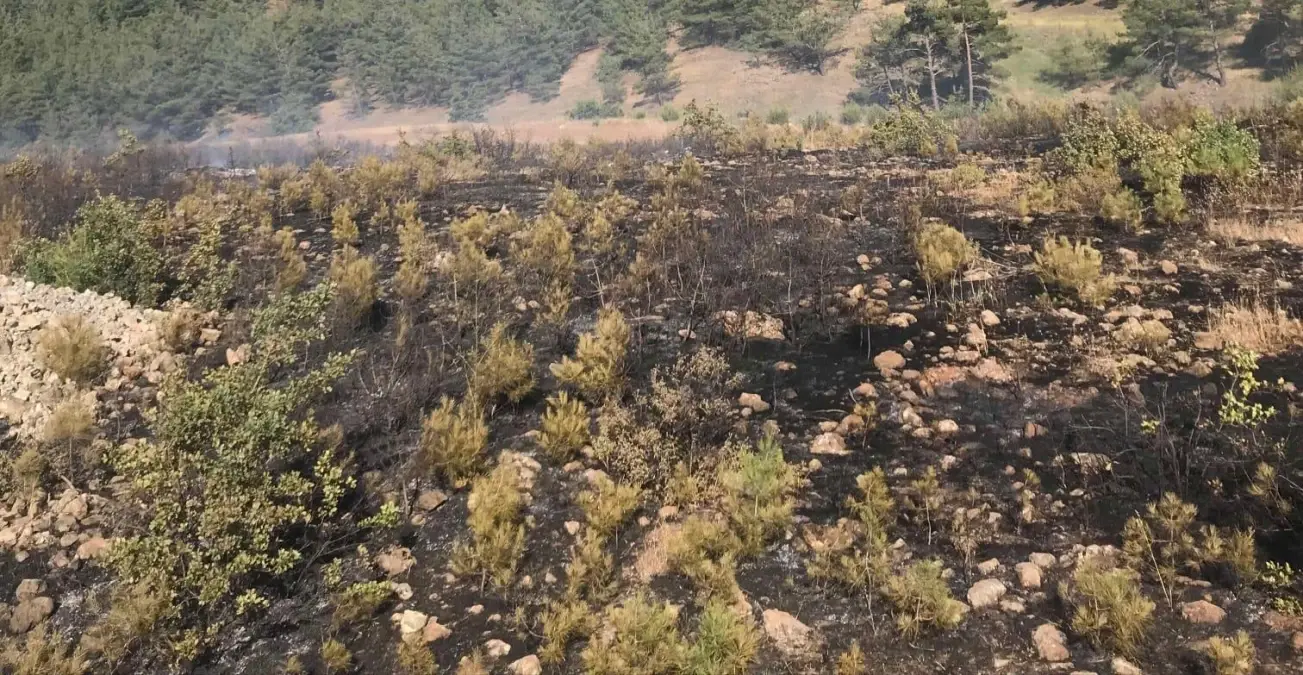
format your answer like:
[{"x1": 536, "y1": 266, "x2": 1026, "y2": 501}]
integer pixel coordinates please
[{"x1": 0, "y1": 104, "x2": 1303, "y2": 675}]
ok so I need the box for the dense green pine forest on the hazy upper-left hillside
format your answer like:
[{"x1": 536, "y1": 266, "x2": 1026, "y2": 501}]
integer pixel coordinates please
[{"x1": 0, "y1": 0, "x2": 656, "y2": 147}]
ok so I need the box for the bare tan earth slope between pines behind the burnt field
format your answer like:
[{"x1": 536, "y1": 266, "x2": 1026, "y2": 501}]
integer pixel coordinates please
[{"x1": 218, "y1": 0, "x2": 1270, "y2": 143}]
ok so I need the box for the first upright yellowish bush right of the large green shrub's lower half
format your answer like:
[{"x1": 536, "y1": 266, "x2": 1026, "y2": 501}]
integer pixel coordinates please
[{"x1": 452, "y1": 463, "x2": 525, "y2": 589}]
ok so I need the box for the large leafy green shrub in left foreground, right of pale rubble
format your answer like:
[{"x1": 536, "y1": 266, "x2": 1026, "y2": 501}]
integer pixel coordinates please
[{"x1": 109, "y1": 285, "x2": 354, "y2": 615}]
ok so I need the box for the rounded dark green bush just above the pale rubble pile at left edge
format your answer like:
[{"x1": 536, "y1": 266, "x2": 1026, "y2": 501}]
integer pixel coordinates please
[{"x1": 22, "y1": 195, "x2": 164, "y2": 305}]
